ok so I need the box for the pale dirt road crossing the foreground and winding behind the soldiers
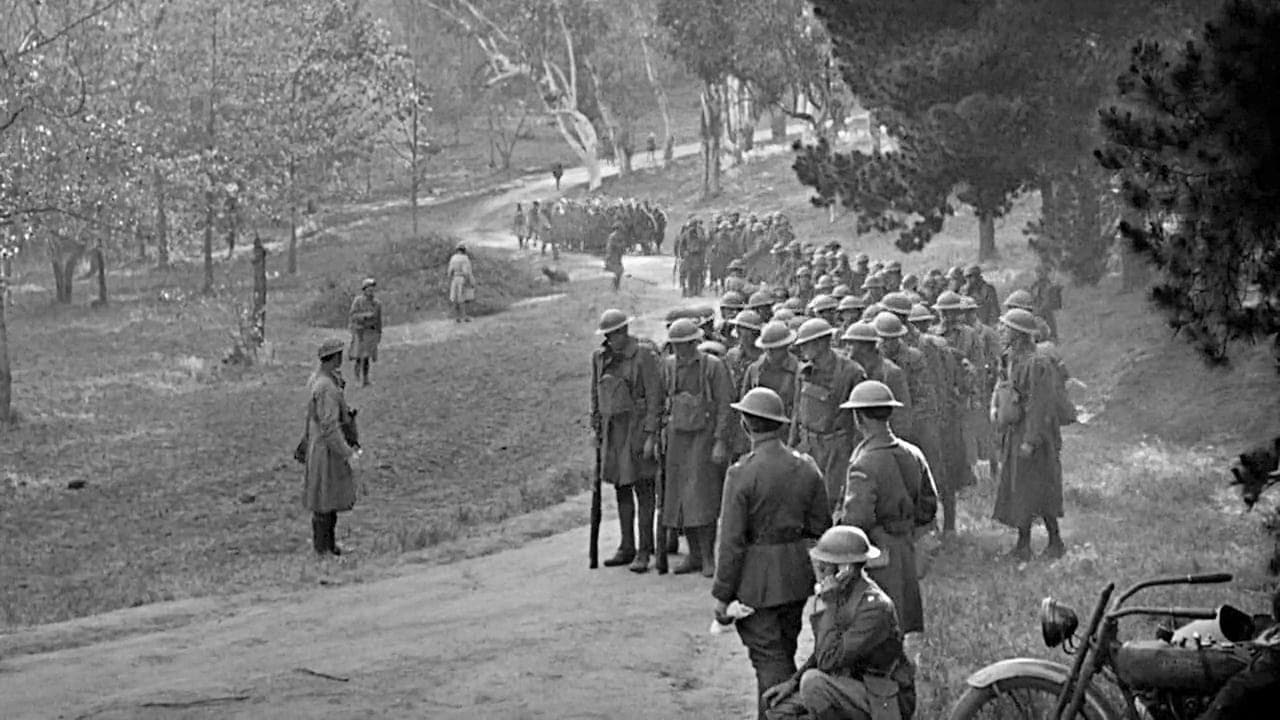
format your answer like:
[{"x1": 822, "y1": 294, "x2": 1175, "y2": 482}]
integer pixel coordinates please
[{"x1": 0, "y1": 148, "x2": 798, "y2": 720}]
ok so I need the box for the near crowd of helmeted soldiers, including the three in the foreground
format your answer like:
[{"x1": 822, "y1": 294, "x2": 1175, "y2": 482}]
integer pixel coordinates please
[{"x1": 593, "y1": 239, "x2": 1070, "y2": 719}]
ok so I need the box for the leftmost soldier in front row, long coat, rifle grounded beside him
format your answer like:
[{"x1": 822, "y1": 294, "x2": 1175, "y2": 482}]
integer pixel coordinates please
[{"x1": 591, "y1": 310, "x2": 664, "y2": 573}]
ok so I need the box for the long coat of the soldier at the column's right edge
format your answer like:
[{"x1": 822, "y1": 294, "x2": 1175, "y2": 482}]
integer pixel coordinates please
[{"x1": 993, "y1": 350, "x2": 1062, "y2": 528}]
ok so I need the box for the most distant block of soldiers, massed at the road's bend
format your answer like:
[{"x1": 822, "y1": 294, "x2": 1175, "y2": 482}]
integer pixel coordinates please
[{"x1": 512, "y1": 197, "x2": 667, "y2": 258}]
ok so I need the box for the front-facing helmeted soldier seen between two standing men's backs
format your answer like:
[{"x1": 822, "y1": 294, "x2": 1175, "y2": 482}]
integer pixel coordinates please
[{"x1": 791, "y1": 318, "x2": 867, "y2": 510}]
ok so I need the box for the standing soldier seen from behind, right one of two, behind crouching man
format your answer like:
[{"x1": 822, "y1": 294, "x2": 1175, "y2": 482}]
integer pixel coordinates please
[{"x1": 838, "y1": 380, "x2": 938, "y2": 633}]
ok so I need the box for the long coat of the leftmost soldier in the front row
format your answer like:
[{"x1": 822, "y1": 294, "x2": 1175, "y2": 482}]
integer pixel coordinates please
[{"x1": 591, "y1": 337, "x2": 666, "y2": 487}]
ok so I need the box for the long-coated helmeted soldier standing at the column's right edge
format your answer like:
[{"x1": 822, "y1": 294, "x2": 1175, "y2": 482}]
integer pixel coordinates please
[{"x1": 991, "y1": 307, "x2": 1066, "y2": 561}]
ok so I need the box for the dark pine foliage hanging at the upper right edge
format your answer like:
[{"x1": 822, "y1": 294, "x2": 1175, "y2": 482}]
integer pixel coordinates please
[{"x1": 1097, "y1": 0, "x2": 1280, "y2": 365}]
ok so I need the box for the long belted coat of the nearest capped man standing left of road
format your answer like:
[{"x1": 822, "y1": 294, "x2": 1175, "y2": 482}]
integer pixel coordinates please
[{"x1": 302, "y1": 370, "x2": 356, "y2": 512}]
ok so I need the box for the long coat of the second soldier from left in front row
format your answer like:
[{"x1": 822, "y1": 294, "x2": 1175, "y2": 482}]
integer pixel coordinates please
[{"x1": 662, "y1": 352, "x2": 736, "y2": 528}]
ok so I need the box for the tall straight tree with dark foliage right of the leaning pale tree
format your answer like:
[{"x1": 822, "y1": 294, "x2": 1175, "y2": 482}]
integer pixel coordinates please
[{"x1": 658, "y1": 0, "x2": 736, "y2": 197}]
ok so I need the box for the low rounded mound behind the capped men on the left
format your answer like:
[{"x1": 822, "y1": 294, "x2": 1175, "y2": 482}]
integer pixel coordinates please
[{"x1": 302, "y1": 233, "x2": 552, "y2": 328}]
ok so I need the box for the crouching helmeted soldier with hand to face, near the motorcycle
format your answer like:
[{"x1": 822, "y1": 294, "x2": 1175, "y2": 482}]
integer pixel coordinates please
[{"x1": 763, "y1": 525, "x2": 915, "y2": 720}]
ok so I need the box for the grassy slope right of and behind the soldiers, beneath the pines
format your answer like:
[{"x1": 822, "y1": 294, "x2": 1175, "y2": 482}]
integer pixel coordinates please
[{"x1": 591, "y1": 152, "x2": 1280, "y2": 717}]
